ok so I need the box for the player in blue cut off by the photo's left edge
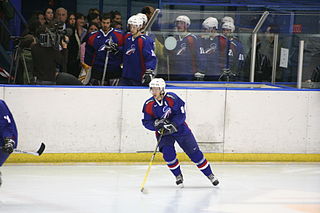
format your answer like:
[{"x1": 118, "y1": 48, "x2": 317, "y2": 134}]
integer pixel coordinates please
[{"x1": 0, "y1": 99, "x2": 18, "y2": 186}]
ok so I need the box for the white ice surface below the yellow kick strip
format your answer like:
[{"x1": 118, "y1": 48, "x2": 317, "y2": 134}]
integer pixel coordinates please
[{"x1": 0, "y1": 163, "x2": 320, "y2": 213}]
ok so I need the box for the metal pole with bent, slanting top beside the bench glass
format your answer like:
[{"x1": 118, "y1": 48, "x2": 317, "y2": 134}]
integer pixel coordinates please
[{"x1": 250, "y1": 11, "x2": 269, "y2": 82}]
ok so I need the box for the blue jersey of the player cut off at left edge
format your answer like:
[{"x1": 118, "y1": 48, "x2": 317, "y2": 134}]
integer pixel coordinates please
[{"x1": 0, "y1": 100, "x2": 18, "y2": 148}]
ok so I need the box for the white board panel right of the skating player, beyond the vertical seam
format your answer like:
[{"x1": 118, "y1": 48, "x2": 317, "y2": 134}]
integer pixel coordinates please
[{"x1": 224, "y1": 90, "x2": 320, "y2": 153}]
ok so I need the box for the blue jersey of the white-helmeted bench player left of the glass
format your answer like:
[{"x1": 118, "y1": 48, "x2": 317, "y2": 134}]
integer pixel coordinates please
[{"x1": 122, "y1": 35, "x2": 157, "y2": 82}]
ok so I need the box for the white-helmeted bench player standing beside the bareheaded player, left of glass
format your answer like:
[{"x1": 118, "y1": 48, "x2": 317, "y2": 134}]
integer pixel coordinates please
[{"x1": 120, "y1": 15, "x2": 157, "y2": 86}]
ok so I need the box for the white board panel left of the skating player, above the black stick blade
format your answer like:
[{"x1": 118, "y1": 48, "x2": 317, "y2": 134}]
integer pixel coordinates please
[{"x1": 5, "y1": 87, "x2": 122, "y2": 153}]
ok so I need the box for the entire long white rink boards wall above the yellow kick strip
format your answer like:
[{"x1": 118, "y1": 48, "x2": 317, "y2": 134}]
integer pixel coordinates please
[{"x1": 0, "y1": 86, "x2": 320, "y2": 153}]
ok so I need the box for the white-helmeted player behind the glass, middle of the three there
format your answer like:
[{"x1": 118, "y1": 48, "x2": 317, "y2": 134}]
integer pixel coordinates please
[{"x1": 195, "y1": 17, "x2": 220, "y2": 81}]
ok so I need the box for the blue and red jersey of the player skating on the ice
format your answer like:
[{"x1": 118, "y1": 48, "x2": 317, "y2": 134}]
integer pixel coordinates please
[{"x1": 142, "y1": 92, "x2": 191, "y2": 135}]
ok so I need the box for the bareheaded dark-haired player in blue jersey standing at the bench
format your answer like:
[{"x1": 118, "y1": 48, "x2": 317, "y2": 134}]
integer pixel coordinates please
[{"x1": 86, "y1": 14, "x2": 123, "y2": 85}]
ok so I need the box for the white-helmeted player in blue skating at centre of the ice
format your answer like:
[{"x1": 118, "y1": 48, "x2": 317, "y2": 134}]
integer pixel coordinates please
[{"x1": 142, "y1": 78, "x2": 219, "y2": 187}]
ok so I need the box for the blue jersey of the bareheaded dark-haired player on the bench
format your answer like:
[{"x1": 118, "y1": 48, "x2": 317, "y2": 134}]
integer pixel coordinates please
[{"x1": 85, "y1": 28, "x2": 123, "y2": 73}]
